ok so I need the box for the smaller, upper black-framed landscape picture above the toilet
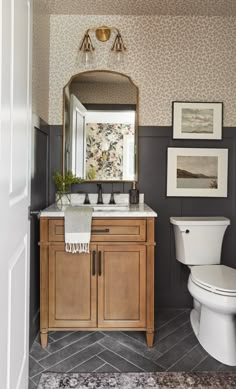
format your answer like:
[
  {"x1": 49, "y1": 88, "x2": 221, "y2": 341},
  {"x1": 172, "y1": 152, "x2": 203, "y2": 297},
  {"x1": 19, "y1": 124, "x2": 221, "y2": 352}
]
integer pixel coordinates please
[{"x1": 172, "y1": 101, "x2": 223, "y2": 139}]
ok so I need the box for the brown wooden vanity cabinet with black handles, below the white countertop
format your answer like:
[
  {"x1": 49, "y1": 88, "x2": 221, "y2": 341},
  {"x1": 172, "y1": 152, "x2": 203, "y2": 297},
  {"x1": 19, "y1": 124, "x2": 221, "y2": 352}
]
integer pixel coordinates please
[{"x1": 40, "y1": 217, "x2": 155, "y2": 347}]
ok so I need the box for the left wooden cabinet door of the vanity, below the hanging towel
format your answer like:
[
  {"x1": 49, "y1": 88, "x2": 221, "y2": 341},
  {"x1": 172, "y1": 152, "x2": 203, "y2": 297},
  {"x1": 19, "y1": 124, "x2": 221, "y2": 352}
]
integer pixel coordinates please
[{"x1": 49, "y1": 245, "x2": 97, "y2": 328}]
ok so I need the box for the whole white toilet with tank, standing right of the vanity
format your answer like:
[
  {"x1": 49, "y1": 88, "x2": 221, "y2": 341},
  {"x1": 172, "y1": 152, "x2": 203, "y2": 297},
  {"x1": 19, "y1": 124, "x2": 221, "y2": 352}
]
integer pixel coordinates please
[{"x1": 170, "y1": 217, "x2": 236, "y2": 366}]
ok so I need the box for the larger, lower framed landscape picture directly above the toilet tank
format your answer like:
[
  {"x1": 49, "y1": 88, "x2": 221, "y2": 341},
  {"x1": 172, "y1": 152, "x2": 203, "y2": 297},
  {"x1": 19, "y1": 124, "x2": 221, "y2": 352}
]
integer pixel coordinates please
[{"x1": 167, "y1": 147, "x2": 228, "y2": 197}]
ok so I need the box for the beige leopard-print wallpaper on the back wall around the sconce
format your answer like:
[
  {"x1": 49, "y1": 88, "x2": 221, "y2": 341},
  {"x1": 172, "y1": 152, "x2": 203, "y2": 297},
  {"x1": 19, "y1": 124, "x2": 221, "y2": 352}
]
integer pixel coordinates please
[{"x1": 48, "y1": 15, "x2": 236, "y2": 126}]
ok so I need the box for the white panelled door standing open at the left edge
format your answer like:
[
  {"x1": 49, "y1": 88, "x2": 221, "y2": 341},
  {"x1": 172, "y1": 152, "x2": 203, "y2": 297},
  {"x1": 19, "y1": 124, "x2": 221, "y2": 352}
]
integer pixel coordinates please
[{"x1": 0, "y1": 0, "x2": 31, "y2": 389}]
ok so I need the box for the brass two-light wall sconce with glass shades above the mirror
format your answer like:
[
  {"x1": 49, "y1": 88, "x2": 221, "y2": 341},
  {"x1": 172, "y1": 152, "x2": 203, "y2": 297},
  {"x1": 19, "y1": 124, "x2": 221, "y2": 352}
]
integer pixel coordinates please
[{"x1": 79, "y1": 26, "x2": 127, "y2": 67}]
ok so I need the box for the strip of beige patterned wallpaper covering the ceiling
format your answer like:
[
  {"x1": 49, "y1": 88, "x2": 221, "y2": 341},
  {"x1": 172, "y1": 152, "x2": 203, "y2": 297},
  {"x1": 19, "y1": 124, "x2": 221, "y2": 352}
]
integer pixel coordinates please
[{"x1": 41, "y1": 0, "x2": 236, "y2": 16}]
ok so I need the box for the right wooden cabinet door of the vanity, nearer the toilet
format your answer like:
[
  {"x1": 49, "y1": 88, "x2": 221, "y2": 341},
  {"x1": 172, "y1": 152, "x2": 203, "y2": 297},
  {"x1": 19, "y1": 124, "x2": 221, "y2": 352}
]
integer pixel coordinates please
[{"x1": 98, "y1": 244, "x2": 146, "y2": 329}]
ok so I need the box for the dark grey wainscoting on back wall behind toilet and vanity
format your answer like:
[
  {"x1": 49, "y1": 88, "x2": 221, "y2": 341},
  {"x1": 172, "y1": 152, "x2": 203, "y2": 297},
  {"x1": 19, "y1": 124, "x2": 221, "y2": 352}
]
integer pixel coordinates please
[{"x1": 49, "y1": 126, "x2": 236, "y2": 308}]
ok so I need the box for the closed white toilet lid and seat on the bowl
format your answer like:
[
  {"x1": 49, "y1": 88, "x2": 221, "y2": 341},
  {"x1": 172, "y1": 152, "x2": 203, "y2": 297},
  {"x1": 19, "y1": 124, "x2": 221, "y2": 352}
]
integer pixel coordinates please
[{"x1": 191, "y1": 265, "x2": 236, "y2": 296}]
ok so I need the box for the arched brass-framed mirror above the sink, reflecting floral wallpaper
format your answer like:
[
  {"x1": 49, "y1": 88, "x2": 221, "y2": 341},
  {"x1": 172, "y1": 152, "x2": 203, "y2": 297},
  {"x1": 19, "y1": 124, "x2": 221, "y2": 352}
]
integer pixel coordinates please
[{"x1": 63, "y1": 71, "x2": 138, "y2": 181}]
